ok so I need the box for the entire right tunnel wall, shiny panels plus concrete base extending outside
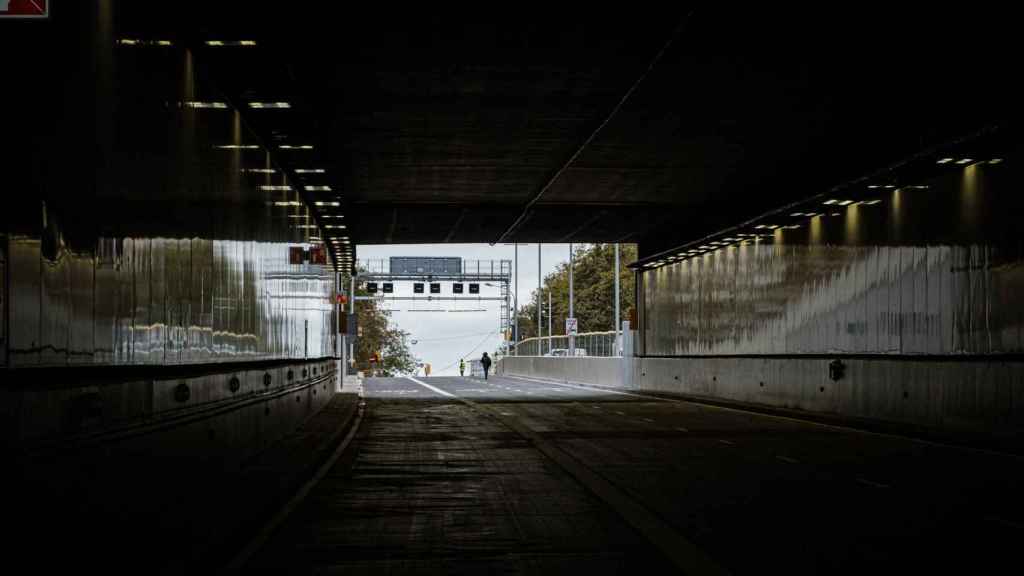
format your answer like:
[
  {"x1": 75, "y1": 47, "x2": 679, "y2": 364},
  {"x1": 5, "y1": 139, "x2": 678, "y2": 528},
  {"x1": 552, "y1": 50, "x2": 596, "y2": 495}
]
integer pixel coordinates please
[{"x1": 498, "y1": 145, "x2": 1024, "y2": 437}]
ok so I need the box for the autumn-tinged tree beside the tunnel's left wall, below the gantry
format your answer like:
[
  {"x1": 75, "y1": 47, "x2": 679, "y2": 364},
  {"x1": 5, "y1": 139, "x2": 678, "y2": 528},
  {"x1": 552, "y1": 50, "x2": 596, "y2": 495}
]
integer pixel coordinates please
[{"x1": 355, "y1": 276, "x2": 419, "y2": 376}]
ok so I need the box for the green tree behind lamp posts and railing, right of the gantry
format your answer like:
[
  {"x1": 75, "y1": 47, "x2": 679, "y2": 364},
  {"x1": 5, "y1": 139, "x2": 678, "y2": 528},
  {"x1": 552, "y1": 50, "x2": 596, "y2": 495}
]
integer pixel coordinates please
[{"x1": 518, "y1": 244, "x2": 637, "y2": 340}]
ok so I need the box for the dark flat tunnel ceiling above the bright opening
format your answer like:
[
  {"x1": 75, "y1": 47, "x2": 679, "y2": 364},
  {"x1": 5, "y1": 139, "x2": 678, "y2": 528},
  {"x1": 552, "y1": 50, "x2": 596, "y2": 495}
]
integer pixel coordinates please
[{"x1": 101, "y1": 2, "x2": 1017, "y2": 250}]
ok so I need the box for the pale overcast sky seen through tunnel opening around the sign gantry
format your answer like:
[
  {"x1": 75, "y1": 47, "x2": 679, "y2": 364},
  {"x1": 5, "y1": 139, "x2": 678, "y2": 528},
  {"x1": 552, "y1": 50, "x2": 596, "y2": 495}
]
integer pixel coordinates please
[{"x1": 358, "y1": 244, "x2": 585, "y2": 376}]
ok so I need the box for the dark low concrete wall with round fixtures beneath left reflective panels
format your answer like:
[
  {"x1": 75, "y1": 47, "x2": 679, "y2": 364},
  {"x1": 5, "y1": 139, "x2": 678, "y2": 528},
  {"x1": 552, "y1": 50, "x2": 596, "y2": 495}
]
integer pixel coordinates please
[{"x1": 0, "y1": 358, "x2": 337, "y2": 448}]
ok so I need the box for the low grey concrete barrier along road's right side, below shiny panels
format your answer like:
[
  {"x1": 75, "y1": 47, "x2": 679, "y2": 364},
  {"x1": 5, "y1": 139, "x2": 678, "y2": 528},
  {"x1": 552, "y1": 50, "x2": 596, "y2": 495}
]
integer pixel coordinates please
[{"x1": 500, "y1": 357, "x2": 1024, "y2": 439}]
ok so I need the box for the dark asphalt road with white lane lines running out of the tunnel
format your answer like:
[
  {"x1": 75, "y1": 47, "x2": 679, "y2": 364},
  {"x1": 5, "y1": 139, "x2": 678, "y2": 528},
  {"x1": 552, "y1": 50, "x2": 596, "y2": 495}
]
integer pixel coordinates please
[{"x1": 247, "y1": 376, "x2": 1024, "y2": 575}]
